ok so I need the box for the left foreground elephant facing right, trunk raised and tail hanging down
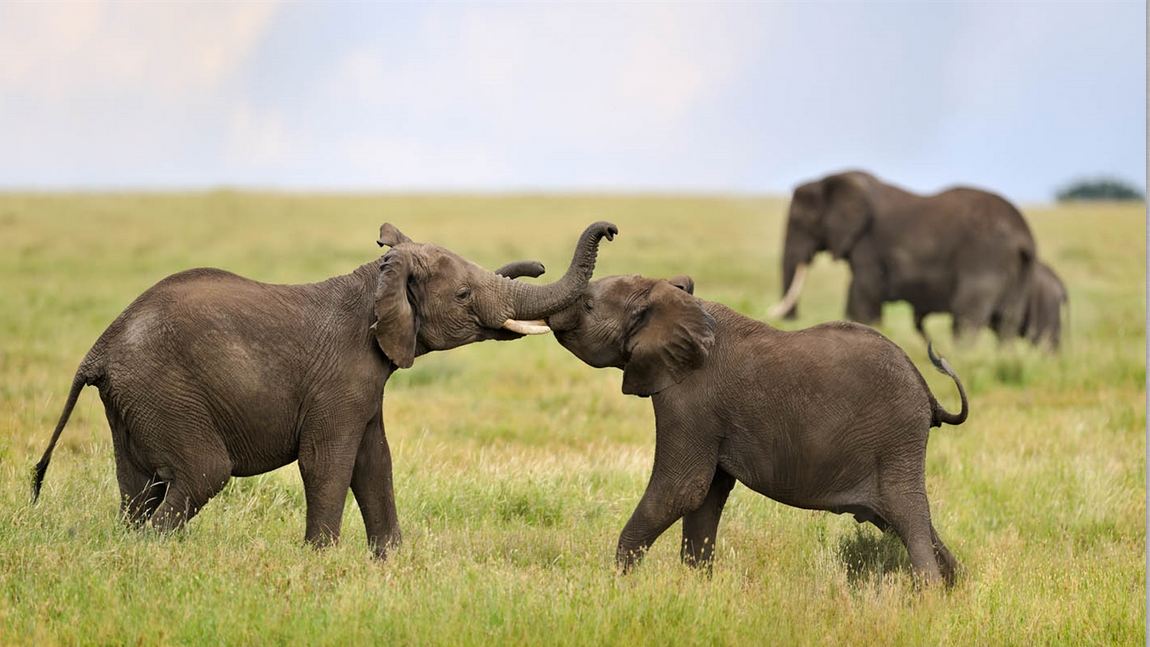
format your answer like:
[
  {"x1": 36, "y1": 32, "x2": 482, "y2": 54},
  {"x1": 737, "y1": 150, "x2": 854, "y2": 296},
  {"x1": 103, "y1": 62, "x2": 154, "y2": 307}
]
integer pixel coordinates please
[{"x1": 32, "y1": 223, "x2": 616, "y2": 557}]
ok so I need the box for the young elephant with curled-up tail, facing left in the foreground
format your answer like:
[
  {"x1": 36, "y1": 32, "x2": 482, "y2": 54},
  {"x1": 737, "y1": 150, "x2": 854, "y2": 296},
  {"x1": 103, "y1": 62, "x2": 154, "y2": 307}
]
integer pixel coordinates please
[{"x1": 547, "y1": 276, "x2": 967, "y2": 584}]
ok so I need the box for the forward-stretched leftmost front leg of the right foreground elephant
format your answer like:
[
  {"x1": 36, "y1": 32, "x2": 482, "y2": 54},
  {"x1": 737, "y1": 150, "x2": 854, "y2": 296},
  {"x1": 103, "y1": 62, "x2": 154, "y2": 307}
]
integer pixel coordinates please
[{"x1": 615, "y1": 429, "x2": 719, "y2": 573}]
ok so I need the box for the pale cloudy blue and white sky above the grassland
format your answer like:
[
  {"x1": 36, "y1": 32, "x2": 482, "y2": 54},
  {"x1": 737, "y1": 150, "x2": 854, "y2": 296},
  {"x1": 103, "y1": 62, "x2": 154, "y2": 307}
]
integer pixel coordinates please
[{"x1": 0, "y1": 1, "x2": 1147, "y2": 201}]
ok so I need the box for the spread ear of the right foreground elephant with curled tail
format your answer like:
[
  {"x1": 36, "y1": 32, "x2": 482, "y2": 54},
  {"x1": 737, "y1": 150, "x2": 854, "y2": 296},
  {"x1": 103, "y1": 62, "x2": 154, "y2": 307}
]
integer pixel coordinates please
[{"x1": 623, "y1": 280, "x2": 715, "y2": 398}]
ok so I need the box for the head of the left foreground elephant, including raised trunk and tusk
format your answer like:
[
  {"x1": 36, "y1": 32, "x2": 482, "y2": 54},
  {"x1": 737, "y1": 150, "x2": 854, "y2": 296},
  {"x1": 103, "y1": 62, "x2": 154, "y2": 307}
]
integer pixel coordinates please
[{"x1": 371, "y1": 222, "x2": 619, "y2": 368}]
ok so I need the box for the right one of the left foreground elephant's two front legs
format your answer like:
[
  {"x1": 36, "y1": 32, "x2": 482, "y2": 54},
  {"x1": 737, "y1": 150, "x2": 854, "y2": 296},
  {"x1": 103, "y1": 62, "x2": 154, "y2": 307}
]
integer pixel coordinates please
[{"x1": 352, "y1": 415, "x2": 403, "y2": 560}]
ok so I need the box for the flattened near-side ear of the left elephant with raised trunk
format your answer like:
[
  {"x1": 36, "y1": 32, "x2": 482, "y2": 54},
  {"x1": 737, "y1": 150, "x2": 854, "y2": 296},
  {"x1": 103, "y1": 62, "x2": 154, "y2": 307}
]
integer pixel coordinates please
[{"x1": 373, "y1": 249, "x2": 419, "y2": 369}]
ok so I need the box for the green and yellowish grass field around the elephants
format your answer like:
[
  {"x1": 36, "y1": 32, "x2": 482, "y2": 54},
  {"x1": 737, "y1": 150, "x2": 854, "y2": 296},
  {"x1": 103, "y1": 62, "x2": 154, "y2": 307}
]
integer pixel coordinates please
[{"x1": 0, "y1": 192, "x2": 1145, "y2": 645}]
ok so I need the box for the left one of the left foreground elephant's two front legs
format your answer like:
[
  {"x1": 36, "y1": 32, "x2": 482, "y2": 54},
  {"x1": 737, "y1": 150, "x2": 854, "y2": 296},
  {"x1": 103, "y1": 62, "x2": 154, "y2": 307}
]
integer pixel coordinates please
[{"x1": 299, "y1": 426, "x2": 363, "y2": 547}]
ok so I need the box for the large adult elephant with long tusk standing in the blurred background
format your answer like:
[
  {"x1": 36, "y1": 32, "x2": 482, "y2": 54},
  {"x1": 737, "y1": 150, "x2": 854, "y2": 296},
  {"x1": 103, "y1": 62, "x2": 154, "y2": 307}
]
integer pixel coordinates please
[{"x1": 771, "y1": 171, "x2": 1036, "y2": 339}]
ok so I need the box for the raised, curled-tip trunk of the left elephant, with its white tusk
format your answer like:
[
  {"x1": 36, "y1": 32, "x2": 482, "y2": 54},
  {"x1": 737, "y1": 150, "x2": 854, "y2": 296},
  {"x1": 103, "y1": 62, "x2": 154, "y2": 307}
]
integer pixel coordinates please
[{"x1": 504, "y1": 222, "x2": 619, "y2": 321}]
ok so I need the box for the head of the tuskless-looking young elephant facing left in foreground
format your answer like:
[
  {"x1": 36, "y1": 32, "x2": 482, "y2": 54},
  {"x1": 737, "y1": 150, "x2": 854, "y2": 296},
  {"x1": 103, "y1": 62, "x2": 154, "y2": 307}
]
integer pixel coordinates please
[{"x1": 547, "y1": 276, "x2": 715, "y2": 396}]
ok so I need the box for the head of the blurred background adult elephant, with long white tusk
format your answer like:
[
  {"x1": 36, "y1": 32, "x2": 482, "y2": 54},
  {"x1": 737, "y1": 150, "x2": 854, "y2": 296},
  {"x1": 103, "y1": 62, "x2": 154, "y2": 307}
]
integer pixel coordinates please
[{"x1": 769, "y1": 171, "x2": 876, "y2": 319}]
